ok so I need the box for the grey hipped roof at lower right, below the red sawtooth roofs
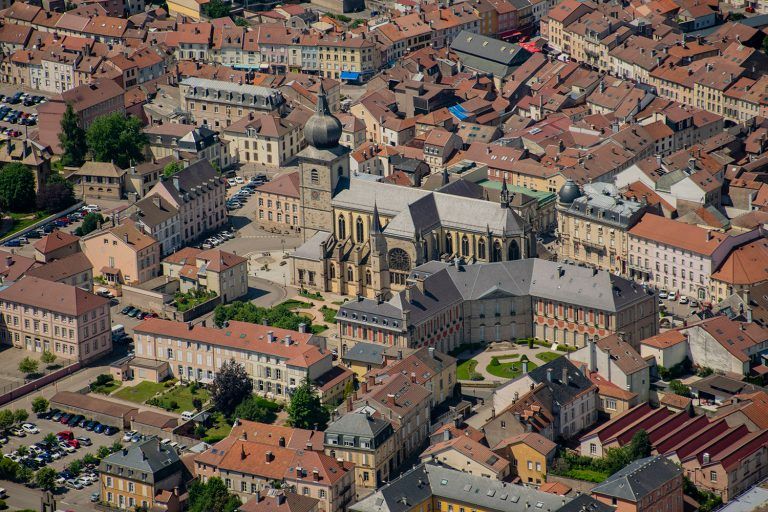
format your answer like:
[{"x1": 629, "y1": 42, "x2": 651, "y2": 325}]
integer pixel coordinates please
[{"x1": 592, "y1": 455, "x2": 682, "y2": 502}]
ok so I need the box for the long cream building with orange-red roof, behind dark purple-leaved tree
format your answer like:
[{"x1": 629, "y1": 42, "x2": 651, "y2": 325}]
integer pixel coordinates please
[{"x1": 134, "y1": 318, "x2": 331, "y2": 400}]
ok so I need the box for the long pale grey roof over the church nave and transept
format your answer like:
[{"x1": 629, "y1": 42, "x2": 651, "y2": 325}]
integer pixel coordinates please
[{"x1": 332, "y1": 179, "x2": 526, "y2": 239}]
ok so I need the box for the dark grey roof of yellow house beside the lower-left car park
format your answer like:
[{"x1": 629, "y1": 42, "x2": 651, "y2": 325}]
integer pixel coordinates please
[{"x1": 100, "y1": 437, "x2": 181, "y2": 481}]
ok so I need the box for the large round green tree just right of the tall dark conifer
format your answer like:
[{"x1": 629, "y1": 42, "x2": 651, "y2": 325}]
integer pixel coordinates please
[{"x1": 86, "y1": 112, "x2": 148, "y2": 169}]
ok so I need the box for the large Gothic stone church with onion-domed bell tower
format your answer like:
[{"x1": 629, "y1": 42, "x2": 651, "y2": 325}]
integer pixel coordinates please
[{"x1": 292, "y1": 85, "x2": 536, "y2": 300}]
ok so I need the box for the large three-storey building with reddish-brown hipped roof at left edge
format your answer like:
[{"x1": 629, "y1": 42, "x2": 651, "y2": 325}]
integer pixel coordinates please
[{"x1": 0, "y1": 277, "x2": 112, "y2": 362}]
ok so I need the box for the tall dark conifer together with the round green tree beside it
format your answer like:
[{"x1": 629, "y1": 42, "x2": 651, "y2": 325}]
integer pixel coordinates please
[{"x1": 59, "y1": 105, "x2": 148, "y2": 169}]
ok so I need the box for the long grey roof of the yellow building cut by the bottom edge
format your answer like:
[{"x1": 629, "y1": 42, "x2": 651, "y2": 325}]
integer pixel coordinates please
[{"x1": 350, "y1": 464, "x2": 570, "y2": 512}]
